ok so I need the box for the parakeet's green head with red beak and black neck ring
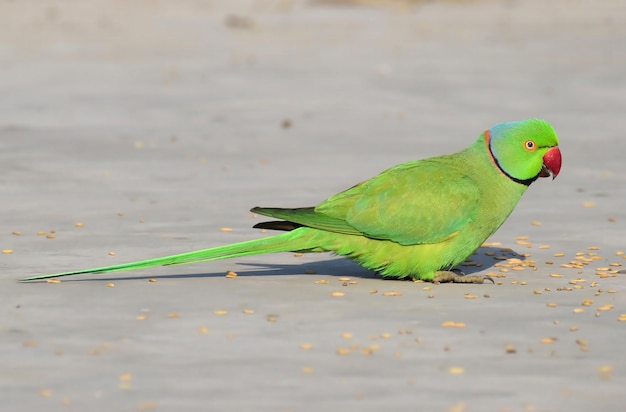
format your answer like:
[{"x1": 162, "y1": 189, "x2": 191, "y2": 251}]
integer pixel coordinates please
[{"x1": 483, "y1": 119, "x2": 561, "y2": 185}]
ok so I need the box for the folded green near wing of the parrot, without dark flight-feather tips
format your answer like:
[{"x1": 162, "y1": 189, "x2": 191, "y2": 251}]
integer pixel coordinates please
[{"x1": 315, "y1": 156, "x2": 481, "y2": 245}]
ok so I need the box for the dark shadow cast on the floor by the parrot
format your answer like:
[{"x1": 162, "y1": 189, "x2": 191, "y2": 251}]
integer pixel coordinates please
[{"x1": 51, "y1": 246, "x2": 525, "y2": 282}]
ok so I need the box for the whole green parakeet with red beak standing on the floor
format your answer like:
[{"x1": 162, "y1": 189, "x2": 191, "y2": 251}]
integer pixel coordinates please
[{"x1": 23, "y1": 119, "x2": 561, "y2": 283}]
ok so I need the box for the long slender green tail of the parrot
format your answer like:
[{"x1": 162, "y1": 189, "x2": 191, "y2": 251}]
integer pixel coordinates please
[{"x1": 22, "y1": 228, "x2": 311, "y2": 281}]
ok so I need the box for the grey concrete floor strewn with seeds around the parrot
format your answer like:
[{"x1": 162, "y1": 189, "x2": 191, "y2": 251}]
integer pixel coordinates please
[{"x1": 0, "y1": 0, "x2": 626, "y2": 412}]
